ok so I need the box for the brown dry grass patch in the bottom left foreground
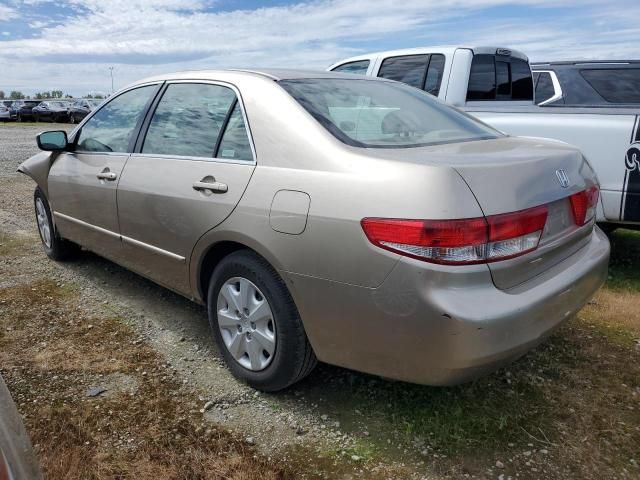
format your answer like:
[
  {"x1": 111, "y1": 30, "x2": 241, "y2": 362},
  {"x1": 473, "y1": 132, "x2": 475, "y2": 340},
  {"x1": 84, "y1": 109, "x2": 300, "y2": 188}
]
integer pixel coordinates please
[{"x1": 0, "y1": 281, "x2": 293, "y2": 480}]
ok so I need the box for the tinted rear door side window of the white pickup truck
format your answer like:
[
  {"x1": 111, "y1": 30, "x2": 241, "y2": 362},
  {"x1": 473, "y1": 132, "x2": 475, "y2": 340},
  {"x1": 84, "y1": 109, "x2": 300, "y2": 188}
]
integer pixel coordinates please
[{"x1": 378, "y1": 54, "x2": 444, "y2": 96}]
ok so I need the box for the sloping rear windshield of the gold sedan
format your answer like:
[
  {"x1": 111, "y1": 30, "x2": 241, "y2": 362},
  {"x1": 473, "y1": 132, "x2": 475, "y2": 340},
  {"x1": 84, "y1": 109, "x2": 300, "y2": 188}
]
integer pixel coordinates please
[{"x1": 280, "y1": 79, "x2": 502, "y2": 148}]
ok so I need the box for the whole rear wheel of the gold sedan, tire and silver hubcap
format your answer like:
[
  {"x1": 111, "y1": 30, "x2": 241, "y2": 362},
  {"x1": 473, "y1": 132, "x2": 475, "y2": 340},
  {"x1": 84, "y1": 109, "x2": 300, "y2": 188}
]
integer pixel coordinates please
[{"x1": 207, "y1": 250, "x2": 317, "y2": 392}]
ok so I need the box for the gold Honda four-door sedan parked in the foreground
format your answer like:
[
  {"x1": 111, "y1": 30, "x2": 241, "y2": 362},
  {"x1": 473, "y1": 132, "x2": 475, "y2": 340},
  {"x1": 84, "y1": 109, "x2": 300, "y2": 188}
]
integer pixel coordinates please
[{"x1": 19, "y1": 70, "x2": 609, "y2": 391}]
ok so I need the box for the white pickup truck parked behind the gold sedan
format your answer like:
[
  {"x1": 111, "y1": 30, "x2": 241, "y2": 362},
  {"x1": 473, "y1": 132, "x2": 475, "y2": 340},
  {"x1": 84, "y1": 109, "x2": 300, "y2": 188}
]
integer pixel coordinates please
[{"x1": 329, "y1": 47, "x2": 640, "y2": 230}]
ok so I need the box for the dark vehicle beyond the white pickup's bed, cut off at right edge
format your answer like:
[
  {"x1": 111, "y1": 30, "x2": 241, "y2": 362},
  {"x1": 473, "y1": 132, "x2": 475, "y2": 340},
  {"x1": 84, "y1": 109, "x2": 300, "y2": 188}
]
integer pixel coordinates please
[{"x1": 531, "y1": 60, "x2": 640, "y2": 108}]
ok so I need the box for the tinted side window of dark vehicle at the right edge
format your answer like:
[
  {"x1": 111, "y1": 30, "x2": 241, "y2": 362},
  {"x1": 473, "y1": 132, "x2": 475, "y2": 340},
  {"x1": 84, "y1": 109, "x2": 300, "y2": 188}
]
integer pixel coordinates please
[{"x1": 580, "y1": 68, "x2": 640, "y2": 103}]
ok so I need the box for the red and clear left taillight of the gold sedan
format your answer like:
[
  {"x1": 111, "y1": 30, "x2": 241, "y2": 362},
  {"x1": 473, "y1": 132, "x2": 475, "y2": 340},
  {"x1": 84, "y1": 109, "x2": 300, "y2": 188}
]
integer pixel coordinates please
[{"x1": 361, "y1": 206, "x2": 548, "y2": 265}]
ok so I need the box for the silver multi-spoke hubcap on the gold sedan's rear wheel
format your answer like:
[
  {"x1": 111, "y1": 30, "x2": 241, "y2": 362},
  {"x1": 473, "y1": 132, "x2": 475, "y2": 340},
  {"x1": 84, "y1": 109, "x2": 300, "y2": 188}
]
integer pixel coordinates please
[{"x1": 217, "y1": 277, "x2": 276, "y2": 372}]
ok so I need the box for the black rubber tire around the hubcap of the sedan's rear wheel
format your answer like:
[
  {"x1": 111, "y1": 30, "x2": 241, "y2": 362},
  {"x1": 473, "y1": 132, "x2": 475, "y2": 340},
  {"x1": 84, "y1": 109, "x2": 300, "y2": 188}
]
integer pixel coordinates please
[{"x1": 207, "y1": 250, "x2": 307, "y2": 392}]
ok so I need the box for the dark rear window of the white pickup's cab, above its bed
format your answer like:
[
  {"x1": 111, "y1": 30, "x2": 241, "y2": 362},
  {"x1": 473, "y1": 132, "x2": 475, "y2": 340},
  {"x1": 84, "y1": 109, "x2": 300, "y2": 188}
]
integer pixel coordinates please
[{"x1": 467, "y1": 54, "x2": 533, "y2": 101}]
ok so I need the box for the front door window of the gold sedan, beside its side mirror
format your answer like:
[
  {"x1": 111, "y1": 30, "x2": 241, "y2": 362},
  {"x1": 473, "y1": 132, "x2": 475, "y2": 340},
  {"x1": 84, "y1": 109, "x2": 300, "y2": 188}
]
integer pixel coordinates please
[{"x1": 76, "y1": 85, "x2": 157, "y2": 152}]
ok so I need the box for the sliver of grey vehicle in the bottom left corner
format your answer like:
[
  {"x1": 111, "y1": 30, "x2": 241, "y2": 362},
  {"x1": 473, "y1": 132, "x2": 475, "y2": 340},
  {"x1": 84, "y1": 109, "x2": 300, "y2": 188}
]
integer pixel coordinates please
[{"x1": 0, "y1": 377, "x2": 42, "y2": 480}]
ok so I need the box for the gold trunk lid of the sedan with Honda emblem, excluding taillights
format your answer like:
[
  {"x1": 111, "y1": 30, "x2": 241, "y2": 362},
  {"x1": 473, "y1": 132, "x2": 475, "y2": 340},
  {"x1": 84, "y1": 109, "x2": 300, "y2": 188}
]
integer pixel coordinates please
[{"x1": 364, "y1": 137, "x2": 597, "y2": 290}]
